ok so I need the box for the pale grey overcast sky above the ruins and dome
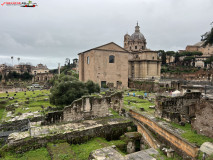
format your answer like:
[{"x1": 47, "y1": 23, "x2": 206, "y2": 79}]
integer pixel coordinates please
[{"x1": 0, "y1": 0, "x2": 213, "y2": 68}]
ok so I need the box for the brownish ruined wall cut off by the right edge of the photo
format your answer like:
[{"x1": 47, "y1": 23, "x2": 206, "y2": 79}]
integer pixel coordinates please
[{"x1": 191, "y1": 99, "x2": 213, "y2": 138}]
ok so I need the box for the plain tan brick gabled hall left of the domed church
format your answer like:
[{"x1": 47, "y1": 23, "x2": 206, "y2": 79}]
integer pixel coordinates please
[{"x1": 79, "y1": 42, "x2": 129, "y2": 87}]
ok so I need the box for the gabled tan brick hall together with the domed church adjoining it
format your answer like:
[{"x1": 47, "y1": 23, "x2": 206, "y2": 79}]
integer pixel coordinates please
[{"x1": 78, "y1": 24, "x2": 161, "y2": 88}]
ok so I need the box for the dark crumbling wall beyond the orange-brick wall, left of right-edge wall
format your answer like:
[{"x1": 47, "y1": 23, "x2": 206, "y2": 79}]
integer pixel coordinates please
[{"x1": 155, "y1": 92, "x2": 201, "y2": 123}]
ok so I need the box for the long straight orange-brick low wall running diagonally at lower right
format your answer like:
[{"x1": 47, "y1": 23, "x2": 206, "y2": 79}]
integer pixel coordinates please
[{"x1": 129, "y1": 110, "x2": 199, "y2": 159}]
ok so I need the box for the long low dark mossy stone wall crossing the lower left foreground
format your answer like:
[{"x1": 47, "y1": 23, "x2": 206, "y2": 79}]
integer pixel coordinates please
[{"x1": 0, "y1": 122, "x2": 133, "y2": 156}]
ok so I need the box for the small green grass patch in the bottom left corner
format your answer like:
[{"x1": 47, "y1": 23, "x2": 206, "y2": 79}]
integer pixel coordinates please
[{"x1": 3, "y1": 148, "x2": 51, "y2": 160}]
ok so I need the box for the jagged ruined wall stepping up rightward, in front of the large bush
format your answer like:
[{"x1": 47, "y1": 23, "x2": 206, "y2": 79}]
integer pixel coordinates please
[{"x1": 44, "y1": 92, "x2": 123, "y2": 124}]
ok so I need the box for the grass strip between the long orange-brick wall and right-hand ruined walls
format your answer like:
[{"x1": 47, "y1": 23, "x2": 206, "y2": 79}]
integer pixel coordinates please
[{"x1": 171, "y1": 122, "x2": 213, "y2": 146}]
